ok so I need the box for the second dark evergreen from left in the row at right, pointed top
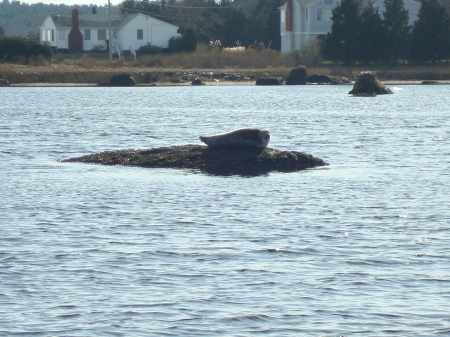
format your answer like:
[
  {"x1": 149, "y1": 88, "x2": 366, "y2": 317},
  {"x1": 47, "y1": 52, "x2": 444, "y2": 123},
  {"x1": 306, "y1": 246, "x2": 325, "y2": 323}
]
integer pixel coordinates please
[{"x1": 358, "y1": 2, "x2": 386, "y2": 62}]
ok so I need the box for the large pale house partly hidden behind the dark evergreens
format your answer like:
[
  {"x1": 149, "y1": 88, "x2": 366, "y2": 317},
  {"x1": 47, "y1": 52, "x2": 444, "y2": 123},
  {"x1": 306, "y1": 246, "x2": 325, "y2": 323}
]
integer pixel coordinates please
[{"x1": 279, "y1": 0, "x2": 421, "y2": 54}]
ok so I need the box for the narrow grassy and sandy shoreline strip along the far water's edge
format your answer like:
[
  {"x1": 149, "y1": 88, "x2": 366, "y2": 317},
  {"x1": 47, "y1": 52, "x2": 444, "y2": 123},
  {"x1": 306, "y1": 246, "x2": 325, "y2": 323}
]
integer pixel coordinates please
[{"x1": 0, "y1": 64, "x2": 450, "y2": 87}]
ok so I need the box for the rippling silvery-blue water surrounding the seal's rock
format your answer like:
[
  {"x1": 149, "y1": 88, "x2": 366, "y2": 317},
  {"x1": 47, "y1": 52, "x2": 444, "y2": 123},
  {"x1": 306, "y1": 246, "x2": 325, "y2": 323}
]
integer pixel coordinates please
[{"x1": 0, "y1": 85, "x2": 450, "y2": 337}]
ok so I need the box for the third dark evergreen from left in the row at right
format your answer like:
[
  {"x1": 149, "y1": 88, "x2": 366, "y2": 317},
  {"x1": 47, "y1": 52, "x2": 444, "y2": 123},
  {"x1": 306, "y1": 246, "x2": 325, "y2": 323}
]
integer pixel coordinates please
[{"x1": 383, "y1": 0, "x2": 411, "y2": 63}]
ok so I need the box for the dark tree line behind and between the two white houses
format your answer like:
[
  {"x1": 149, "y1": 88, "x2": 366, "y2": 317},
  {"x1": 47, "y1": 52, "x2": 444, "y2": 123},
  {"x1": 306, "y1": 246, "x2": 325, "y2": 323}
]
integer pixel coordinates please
[{"x1": 119, "y1": 0, "x2": 285, "y2": 50}]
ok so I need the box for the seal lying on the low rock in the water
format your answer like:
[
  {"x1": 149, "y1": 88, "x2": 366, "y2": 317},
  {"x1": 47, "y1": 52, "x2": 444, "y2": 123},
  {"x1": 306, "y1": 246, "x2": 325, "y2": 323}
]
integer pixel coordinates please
[{"x1": 200, "y1": 128, "x2": 270, "y2": 149}]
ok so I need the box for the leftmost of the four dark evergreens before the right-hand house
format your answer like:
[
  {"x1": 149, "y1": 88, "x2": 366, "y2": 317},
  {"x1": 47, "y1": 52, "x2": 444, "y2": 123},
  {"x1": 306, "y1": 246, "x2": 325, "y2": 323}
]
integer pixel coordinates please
[{"x1": 323, "y1": 0, "x2": 361, "y2": 64}]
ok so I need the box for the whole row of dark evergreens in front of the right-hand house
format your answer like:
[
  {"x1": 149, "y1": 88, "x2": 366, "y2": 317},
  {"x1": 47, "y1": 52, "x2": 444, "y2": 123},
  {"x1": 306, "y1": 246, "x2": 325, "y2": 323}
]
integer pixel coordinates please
[{"x1": 323, "y1": 0, "x2": 450, "y2": 64}]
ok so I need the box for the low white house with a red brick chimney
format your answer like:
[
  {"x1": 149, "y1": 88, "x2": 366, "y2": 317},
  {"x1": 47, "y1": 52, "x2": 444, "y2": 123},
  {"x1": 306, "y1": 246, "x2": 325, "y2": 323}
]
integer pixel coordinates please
[{"x1": 39, "y1": 9, "x2": 178, "y2": 52}]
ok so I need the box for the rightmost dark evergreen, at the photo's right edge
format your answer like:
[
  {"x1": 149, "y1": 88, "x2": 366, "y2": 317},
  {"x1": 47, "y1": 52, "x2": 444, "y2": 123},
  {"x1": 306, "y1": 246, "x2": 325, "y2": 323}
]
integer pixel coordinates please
[{"x1": 410, "y1": 0, "x2": 450, "y2": 62}]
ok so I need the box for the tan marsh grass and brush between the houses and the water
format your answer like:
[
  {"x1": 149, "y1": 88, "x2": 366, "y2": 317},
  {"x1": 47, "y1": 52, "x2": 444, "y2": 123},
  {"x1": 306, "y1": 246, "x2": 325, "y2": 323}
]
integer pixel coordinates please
[{"x1": 0, "y1": 46, "x2": 450, "y2": 83}]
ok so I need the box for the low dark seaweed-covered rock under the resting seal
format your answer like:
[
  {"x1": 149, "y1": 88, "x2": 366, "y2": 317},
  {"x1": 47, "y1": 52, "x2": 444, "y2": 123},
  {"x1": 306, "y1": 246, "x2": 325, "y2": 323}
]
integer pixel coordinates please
[{"x1": 61, "y1": 145, "x2": 328, "y2": 176}]
